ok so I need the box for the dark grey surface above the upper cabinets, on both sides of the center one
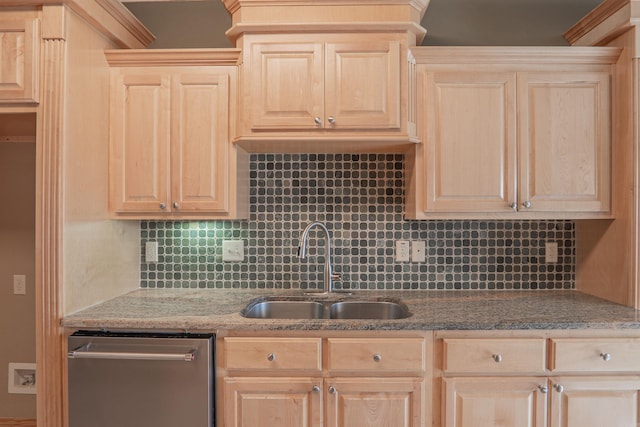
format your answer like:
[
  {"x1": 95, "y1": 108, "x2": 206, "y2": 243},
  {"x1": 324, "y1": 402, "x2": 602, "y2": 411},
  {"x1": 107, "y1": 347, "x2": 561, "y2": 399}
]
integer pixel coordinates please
[{"x1": 123, "y1": 0, "x2": 602, "y2": 48}]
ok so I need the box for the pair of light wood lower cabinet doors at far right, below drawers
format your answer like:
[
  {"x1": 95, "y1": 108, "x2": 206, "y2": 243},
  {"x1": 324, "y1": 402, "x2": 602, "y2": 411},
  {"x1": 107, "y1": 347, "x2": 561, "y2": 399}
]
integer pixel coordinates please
[{"x1": 444, "y1": 376, "x2": 640, "y2": 427}]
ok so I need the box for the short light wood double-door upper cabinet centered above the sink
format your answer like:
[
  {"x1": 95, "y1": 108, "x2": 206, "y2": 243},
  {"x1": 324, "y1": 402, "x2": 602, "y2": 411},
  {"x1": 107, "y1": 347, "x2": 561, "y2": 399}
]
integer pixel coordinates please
[{"x1": 239, "y1": 34, "x2": 414, "y2": 151}]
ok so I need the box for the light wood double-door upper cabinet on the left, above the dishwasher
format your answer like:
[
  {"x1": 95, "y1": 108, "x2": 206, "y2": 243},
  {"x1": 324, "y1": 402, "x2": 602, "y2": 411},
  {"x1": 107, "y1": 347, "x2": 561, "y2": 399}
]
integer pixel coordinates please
[{"x1": 107, "y1": 51, "x2": 248, "y2": 219}]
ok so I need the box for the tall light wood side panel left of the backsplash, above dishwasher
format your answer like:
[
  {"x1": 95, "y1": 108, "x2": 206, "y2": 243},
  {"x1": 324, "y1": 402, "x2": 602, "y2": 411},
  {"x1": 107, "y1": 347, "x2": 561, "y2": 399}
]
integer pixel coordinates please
[{"x1": 63, "y1": 5, "x2": 140, "y2": 313}]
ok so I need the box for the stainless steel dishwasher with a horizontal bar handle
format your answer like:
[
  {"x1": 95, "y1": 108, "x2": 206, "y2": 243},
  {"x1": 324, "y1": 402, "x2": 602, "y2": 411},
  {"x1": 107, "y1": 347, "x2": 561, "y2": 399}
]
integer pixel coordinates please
[{"x1": 68, "y1": 331, "x2": 215, "y2": 427}]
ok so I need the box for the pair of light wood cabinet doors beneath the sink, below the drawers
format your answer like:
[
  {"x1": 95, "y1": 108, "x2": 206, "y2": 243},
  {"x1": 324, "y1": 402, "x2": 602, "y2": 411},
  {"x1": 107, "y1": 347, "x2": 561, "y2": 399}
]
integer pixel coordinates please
[{"x1": 225, "y1": 377, "x2": 424, "y2": 427}]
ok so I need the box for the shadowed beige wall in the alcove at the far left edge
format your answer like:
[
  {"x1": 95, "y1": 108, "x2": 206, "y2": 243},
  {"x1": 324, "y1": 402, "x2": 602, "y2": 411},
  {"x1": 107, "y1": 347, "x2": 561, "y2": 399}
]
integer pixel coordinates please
[{"x1": 0, "y1": 142, "x2": 36, "y2": 418}]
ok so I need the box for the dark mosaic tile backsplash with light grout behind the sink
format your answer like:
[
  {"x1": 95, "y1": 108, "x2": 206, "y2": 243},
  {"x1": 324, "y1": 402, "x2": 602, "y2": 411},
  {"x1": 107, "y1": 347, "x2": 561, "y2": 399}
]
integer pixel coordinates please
[{"x1": 140, "y1": 154, "x2": 575, "y2": 290}]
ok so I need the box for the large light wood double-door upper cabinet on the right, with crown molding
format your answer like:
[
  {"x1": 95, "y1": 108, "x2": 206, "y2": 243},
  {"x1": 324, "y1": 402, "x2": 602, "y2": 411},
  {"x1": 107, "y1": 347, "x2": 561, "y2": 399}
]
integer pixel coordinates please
[{"x1": 406, "y1": 48, "x2": 619, "y2": 219}]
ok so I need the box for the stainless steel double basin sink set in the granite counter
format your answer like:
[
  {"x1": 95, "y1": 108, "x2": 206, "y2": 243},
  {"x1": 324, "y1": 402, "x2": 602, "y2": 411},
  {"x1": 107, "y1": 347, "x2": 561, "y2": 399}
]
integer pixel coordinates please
[{"x1": 241, "y1": 294, "x2": 411, "y2": 320}]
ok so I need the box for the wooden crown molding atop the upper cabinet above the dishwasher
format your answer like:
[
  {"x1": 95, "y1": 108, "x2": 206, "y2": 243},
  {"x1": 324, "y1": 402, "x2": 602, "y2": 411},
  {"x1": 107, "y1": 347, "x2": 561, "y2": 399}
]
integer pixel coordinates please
[{"x1": 105, "y1": 49, "x2": 241, "y2": 67}]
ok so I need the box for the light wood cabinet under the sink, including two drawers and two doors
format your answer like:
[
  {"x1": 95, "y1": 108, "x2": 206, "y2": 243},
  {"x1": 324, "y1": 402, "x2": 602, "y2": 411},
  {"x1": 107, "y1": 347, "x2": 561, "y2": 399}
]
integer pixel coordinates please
[{"x1": 222, "y1": 337, "x2": 430, "y2": 427}]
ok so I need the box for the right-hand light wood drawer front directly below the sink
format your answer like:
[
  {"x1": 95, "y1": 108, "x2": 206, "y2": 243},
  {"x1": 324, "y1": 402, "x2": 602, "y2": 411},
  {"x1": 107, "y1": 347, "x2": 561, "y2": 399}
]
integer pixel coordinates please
[{"x1": 327, "y1": 338, "x2": 425, "y2": 373}]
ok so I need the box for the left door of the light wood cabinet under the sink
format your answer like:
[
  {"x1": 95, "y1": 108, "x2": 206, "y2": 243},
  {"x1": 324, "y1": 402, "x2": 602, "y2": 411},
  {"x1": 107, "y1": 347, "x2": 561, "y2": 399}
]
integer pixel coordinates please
[{"x1": 224, "y1": 378, "x2": 322, "y2": 427}]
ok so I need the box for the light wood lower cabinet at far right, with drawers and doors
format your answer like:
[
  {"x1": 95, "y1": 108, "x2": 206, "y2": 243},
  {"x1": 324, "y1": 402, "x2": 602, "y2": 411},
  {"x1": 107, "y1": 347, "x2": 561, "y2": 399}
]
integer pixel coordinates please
[{"x1": 440, "y1": 336, "x2": 640, "y2": 427}]
